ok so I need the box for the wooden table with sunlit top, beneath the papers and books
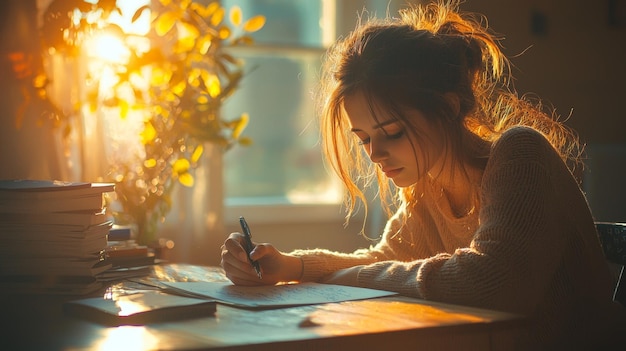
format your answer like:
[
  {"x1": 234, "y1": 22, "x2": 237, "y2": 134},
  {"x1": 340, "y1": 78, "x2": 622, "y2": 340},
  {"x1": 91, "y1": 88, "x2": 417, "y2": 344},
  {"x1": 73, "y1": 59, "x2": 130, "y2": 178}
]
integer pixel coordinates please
[{"x1": 0, "y1": 265, "x2": 524, "y2": 351}]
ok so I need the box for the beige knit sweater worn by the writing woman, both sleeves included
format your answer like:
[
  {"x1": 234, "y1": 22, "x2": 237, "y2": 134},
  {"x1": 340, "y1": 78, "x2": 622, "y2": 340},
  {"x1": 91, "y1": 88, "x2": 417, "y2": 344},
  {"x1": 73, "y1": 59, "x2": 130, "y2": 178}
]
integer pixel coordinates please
[{"x1": 292, "y1": 127, "x2": 621, "y2": 349}]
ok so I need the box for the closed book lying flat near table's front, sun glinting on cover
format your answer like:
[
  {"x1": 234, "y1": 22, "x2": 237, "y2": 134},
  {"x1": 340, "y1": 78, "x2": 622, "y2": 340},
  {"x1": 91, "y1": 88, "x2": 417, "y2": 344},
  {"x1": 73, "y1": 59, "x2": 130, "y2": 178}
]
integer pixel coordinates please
[{"x1": 63, "y1": 290, "x2": 216, "y2": 326}]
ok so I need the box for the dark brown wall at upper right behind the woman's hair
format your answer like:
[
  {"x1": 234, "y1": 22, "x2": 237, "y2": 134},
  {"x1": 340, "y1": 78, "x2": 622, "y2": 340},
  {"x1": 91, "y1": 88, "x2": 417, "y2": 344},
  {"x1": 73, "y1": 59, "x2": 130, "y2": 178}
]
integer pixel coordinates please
[{"x1": 462, "y1": 0, "x2": 626, "y2": 221}]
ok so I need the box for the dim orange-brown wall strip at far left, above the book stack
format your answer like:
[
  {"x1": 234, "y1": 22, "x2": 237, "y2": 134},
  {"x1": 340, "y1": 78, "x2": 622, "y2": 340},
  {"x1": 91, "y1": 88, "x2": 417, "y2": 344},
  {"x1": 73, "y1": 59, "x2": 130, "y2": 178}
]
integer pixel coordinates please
[{"x1": 0, "y1": 0, "x2": 64, "y2": 179}]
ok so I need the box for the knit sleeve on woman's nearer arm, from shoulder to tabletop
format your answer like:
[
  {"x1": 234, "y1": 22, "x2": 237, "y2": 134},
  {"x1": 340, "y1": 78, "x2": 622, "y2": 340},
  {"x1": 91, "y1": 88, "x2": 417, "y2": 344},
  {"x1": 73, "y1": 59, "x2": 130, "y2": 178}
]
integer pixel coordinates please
[{"x1": 358, "y1": 128, "x2": 570, "y2": 311}]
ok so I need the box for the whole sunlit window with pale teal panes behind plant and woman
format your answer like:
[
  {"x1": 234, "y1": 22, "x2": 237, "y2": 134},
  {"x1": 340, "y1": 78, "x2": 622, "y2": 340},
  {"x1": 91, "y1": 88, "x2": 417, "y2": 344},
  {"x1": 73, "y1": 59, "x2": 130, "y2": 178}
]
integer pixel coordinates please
[{"x1": 223, "y1": 0, "x2": 408, "y2": 221}]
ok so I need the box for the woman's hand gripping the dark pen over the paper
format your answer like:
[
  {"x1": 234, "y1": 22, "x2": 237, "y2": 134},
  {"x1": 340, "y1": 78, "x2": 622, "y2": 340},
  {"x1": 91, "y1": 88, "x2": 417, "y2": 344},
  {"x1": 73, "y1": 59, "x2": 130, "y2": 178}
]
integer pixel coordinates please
[{"x1": 221, "y1": 232, "x2": 302, "y2": 286}]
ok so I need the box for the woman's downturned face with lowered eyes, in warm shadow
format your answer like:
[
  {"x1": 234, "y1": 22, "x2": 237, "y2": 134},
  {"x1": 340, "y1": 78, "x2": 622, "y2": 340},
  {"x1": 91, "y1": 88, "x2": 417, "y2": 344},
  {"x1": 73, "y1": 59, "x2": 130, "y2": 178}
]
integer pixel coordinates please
[{"x1": 344, "y1": 93, "x2": 445, "y2": 187}]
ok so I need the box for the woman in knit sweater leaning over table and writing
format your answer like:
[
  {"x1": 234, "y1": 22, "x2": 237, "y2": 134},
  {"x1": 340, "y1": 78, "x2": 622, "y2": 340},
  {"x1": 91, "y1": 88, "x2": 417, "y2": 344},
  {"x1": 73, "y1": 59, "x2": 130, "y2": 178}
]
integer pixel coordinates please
[{"x1": 222, "y1": 1, "x2": 622, "y2": 349}]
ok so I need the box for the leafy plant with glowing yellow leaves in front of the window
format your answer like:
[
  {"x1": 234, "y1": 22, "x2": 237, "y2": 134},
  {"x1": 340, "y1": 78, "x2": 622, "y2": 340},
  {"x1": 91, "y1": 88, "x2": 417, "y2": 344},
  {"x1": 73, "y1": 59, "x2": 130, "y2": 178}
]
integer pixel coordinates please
[{"x1": 37, "y1": 0, "x2": 265, "y2": 244}]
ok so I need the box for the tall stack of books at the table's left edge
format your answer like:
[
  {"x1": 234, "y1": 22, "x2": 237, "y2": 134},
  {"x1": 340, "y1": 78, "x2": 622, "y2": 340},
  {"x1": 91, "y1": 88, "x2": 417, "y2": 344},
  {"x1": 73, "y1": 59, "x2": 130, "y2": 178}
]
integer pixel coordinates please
[{"x1": 0, "y1": 180, "x2": 114, "y2": 294}]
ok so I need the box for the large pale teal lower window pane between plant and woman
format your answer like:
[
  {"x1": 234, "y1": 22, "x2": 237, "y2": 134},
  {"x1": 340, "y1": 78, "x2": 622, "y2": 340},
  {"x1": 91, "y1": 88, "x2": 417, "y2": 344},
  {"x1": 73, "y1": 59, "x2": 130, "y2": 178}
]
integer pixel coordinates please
[{"x1": 223, "y1": 54, "x2": 338, "y2": 202}]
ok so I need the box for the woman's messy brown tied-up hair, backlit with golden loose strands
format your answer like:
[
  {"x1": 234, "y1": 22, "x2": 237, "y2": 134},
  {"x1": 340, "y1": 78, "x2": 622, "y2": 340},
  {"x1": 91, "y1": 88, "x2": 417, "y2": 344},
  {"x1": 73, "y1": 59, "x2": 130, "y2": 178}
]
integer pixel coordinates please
[{"x1": 319, "y1": 0, "x2": 580, "y2": 223}]
